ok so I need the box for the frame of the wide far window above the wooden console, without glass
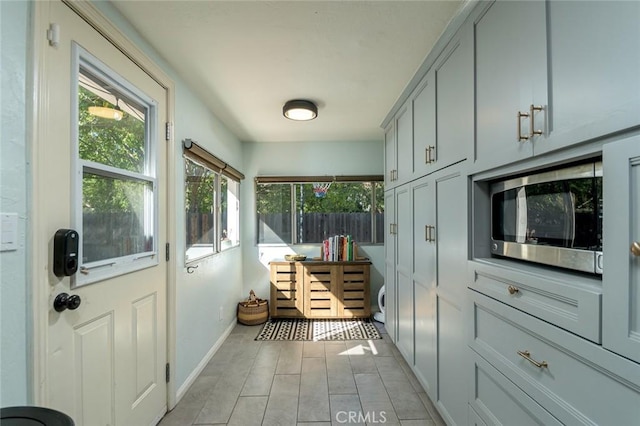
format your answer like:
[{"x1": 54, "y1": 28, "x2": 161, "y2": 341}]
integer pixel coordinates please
[{"x1": 254, "y1": 175, "x2": 384, "y2": 246}]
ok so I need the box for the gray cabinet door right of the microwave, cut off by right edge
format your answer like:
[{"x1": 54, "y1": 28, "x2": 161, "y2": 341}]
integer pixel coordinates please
[{"x1": 602, "y1": 136, "x2": 640, "y2": 362}]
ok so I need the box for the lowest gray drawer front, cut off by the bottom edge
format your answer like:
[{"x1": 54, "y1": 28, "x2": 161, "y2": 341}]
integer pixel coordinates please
[{"x1": 469, "y1": 354, "x2": 562, "y2": 426}]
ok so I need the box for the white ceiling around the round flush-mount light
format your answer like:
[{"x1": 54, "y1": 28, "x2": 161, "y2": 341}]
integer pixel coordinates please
[{"x1": 113, "y1": 0, "x2": 461, "y2": 142}]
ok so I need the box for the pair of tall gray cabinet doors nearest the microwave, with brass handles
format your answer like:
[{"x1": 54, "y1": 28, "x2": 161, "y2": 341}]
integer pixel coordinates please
[{"x1": 412, "y1": 166, "x2": 468, "y2": 424}]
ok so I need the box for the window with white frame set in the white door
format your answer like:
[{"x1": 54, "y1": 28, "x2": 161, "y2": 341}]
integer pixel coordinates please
[{"x1": 74, "y1": 46, "x2": 158, "y2": 285}]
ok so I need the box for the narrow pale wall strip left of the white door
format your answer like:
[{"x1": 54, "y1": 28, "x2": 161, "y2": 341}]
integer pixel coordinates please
[{"x1": 0, "y1": 1, "x2": 31, "y2": 407}]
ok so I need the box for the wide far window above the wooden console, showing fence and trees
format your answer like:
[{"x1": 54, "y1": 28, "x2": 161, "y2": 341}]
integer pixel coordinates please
[{"x1": 256, "y1": 176, "x2": 384, "y2": 244}]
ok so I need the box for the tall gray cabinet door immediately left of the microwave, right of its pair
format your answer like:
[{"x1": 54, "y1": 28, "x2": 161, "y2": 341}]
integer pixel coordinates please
[{"x1": 432, "y1": 171, "x2": 468, "y2": 425}]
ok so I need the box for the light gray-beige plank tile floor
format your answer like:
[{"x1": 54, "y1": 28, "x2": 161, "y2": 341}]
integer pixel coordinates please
[{"x1": 160, "y1": 323, "x2": 444, "y2": 426}]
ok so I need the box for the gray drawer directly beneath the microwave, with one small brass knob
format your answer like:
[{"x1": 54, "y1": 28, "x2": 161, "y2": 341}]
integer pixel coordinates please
[{"x1": 470, "y1": 262, "x2": 602, "y2": 343}]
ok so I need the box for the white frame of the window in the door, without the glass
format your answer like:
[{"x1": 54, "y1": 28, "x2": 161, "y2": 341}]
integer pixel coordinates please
[{"x1": 71, "y1": 42, "x2": 160, "y2": 288}]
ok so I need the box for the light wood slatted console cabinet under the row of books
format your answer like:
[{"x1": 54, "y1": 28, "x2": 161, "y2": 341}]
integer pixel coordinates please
[{"x1": 269, "y1": 261, "x2": 371, "y2": 318}]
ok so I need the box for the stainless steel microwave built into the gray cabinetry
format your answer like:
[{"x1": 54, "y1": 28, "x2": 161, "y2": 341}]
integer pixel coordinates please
[{"x1": 491, "y1": 161, "x2": 602, "y2": 274}]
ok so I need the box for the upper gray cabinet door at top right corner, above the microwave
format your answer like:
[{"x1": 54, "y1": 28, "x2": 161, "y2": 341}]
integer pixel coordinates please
[{"x1": 534, "y1": 1, "x2": 640, "y2": 154}]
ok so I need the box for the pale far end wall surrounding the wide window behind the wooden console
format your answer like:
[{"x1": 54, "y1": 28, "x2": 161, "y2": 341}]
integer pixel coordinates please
[{"x1": 241, "y1": 140, "x2": 384, "y2": 306}]
